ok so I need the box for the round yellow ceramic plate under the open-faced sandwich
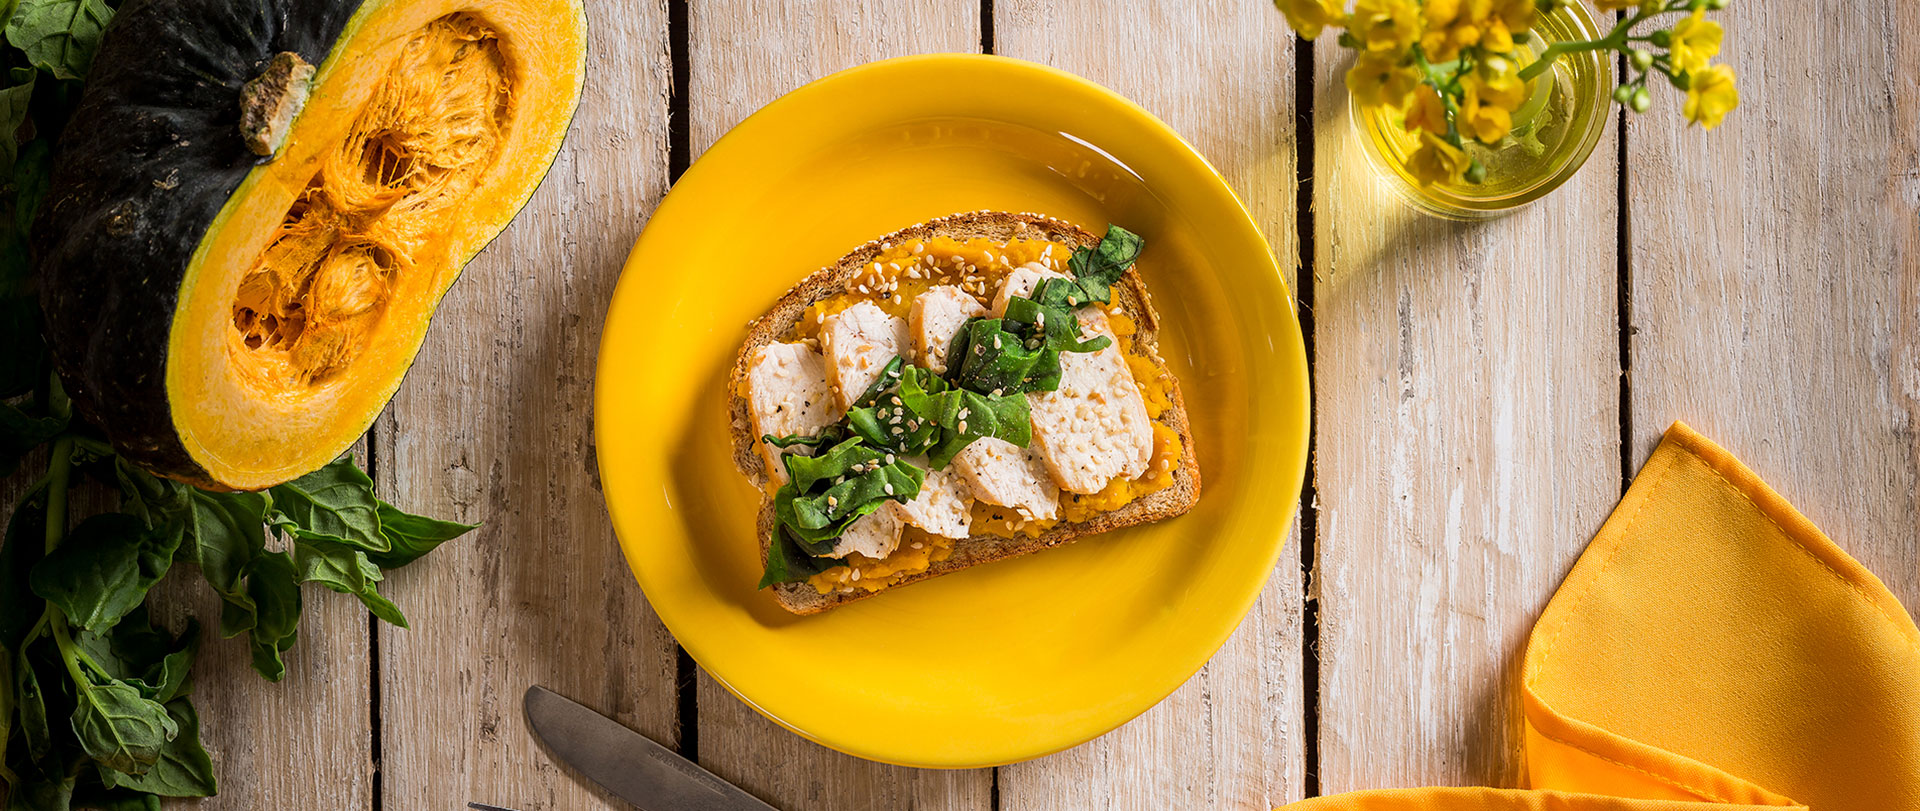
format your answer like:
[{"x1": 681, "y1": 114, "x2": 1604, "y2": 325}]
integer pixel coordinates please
[{"x1": 595, "y1": 56, "x2": 1308, "y2": 767}]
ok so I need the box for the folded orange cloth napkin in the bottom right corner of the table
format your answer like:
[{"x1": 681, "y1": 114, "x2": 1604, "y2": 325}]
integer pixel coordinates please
[{"x1": 1286, "y1": 423, "x2": 1920, "y2": 811}]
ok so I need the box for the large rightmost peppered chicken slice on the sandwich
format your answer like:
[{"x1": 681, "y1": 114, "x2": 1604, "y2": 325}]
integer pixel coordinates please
[{"x1": 1027, "y1": 307, "x2": 1154, "y2": 494}]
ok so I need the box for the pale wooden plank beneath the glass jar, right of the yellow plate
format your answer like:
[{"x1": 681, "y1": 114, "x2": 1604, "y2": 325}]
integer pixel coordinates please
[{"x1": 1313, "y1": 49, "x2": 1620, "y2": 794}]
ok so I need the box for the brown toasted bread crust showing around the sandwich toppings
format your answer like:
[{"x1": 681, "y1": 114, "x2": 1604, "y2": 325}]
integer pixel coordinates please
[{"x1": 728, "y1": 211, "x2": 1200, "y2": 615}]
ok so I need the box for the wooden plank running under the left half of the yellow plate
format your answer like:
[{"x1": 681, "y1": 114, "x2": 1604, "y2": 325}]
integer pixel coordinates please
[{"x1": 687, "y1": 0, "x2": 991, "y2": 811}]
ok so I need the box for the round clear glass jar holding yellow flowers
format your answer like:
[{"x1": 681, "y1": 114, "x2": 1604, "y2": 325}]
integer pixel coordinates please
[{"x1": 1350, "y1": 2, "x2": 1613, "y2": 219}]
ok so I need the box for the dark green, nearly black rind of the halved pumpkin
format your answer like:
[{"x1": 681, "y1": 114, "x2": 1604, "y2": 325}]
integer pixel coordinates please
[{"x1": 33, "y1": 0, "x2": 361, "y2": 486}]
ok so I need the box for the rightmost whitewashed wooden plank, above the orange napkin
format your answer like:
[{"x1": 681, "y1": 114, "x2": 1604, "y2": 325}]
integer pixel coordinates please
[{"x1": 1628, "y1": 2, "x2": 1920, "y2": 609}]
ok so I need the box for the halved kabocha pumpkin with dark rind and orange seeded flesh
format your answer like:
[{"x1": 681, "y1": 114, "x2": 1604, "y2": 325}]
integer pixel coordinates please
[{"x1": 35, "y1": 0, "x2": 586, "y2": 490}]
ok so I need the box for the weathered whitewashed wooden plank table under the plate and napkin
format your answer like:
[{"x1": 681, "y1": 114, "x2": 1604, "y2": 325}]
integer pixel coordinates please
[{"x1": 127, "y1": 0, "x2": 1920, "y2": 811}]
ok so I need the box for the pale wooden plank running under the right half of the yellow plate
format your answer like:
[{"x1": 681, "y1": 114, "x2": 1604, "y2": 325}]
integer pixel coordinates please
[{"x1": 995, "y1": 0, "x2": 1306, "y2": 809}]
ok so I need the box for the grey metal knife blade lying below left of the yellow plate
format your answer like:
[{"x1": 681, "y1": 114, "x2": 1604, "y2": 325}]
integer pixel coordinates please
[{"x1": 526, "y1": 684, "x2": 774, "y2": 811}]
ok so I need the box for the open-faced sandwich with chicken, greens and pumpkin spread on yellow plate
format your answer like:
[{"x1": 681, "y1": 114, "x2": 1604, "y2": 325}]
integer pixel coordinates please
[{"x1": 730, "y1": 211, "x2": 1200, "y2": 613}]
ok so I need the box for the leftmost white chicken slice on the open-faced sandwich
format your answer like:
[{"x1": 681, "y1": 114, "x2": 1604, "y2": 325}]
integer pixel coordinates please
[{"x1": 747, "y1": 344, "x2": 839, "y2": 484}]
